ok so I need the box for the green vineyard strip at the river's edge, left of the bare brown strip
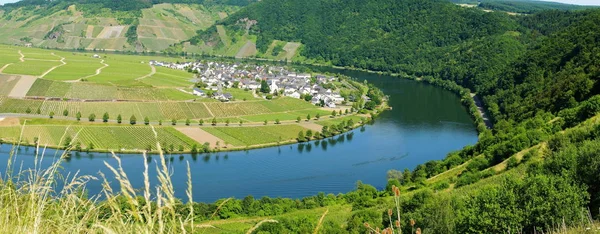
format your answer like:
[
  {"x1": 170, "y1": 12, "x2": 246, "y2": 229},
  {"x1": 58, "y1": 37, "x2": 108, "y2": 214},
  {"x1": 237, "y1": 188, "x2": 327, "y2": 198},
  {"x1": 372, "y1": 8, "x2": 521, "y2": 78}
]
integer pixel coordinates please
[{"x1": 0, "y1": 125, "x2": 198, "y2": 151}]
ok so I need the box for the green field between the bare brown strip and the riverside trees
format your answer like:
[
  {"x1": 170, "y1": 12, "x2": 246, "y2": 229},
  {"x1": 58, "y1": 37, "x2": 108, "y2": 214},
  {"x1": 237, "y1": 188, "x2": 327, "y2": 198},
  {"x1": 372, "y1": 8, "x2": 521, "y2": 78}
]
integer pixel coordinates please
[{"x1": 202, "y1": 124, "x2": 307, "y2": 146}]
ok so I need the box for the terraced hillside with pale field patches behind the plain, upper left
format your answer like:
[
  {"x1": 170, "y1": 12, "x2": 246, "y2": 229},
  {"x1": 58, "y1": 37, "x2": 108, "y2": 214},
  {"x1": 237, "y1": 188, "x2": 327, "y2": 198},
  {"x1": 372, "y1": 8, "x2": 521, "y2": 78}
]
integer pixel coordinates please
[{"x1": 0, "y1": 1, "x2": 246, "y2": 52}]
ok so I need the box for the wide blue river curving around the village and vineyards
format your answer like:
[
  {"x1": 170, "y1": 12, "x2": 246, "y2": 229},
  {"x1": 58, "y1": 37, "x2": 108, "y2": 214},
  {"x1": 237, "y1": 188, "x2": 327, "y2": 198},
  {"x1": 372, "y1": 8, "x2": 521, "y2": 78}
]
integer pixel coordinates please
[{"x1": 0, "y1": 70, "x2": 477, "y2": 202}]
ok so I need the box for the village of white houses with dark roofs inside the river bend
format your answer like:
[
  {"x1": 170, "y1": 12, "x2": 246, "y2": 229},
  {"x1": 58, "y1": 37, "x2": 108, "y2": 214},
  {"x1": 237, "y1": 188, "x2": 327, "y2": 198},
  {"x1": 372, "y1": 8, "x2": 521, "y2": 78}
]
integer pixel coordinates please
[{"x1": 150, "y1": 61, "x2": 345, "y2": 108}]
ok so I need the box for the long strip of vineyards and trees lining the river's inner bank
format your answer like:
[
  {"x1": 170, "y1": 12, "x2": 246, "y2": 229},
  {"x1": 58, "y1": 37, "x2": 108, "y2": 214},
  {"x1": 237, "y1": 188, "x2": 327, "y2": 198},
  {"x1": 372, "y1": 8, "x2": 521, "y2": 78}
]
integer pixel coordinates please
[{"x1": 0, "y1": 104, "x2": 387, "y2": 154}]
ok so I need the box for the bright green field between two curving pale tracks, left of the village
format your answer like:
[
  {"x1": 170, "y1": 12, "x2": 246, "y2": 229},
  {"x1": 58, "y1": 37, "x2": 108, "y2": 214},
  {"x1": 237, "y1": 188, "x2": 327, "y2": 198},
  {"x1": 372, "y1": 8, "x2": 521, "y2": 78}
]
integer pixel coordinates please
[{"x1": 44, "y1": 59, "x2": 104, "y2": 80}]
